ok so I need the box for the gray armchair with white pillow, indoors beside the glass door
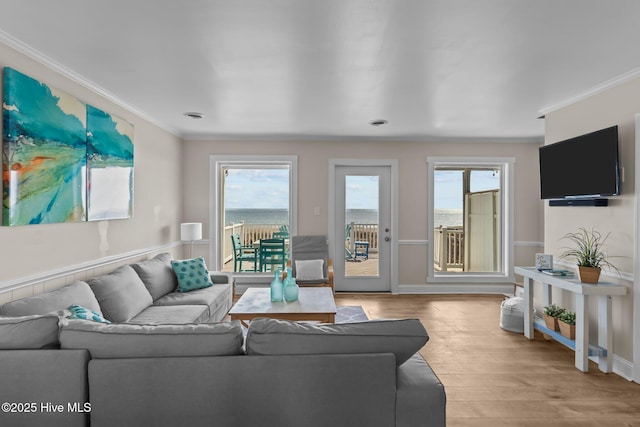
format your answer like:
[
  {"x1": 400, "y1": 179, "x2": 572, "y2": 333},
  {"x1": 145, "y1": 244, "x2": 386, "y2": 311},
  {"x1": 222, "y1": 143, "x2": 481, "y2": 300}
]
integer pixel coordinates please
[{"x1": 285, "y1": 236, "x2": 334, "y2": 291}]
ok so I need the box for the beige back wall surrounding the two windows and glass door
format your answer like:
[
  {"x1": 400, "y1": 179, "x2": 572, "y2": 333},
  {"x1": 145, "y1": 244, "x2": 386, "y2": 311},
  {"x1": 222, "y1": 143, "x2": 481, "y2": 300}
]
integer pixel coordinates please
[{"x1": 183, "y1": 141, "x2": 543, "y2": 286}]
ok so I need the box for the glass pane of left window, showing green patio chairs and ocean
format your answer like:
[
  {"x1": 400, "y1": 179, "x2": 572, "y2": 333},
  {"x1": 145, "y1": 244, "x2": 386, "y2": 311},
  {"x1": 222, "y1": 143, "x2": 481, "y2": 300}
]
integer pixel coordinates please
[{"x1": 220, "y1": 166, "x2": 290, "y2": 272}]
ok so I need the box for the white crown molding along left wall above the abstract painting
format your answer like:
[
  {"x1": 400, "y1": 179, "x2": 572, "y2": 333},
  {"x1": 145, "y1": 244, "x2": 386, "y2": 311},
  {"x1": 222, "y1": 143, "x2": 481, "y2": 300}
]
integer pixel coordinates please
[{"x1": 0, "y1": 30, "x2": 181, "y2": 138}]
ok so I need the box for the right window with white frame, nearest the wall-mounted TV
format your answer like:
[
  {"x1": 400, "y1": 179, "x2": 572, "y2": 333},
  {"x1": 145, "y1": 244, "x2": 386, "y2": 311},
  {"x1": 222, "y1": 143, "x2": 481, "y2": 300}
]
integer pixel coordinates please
[{"x1": 427, "y1": 158, "x2": 514, "y2": 282}]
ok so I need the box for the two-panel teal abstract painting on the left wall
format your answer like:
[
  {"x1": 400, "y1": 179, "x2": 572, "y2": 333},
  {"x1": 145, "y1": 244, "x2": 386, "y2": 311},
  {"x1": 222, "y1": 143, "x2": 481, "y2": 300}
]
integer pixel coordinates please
[{"x1": 2, "y1": 67, "x2": 133, "y2": 225}]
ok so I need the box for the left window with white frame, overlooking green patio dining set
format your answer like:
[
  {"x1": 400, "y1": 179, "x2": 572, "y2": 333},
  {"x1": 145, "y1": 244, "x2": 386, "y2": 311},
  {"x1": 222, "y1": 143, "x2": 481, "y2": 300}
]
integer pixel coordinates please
[{"x1": 210, "y1": 156, "x2": 297, "y2": 277}]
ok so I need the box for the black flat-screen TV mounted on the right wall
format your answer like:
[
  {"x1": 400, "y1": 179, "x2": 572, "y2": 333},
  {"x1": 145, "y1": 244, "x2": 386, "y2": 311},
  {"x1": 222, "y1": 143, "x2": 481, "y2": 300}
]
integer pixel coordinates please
[{"x1": 539, "y1": 126, "x2": 620, "y2": 199}]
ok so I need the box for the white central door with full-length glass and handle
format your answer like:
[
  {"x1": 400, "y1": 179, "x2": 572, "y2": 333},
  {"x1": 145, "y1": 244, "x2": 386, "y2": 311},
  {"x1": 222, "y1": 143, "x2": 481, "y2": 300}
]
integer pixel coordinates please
[{"x1": 330, "y1": 164, "x2": 395, "y2": 292}]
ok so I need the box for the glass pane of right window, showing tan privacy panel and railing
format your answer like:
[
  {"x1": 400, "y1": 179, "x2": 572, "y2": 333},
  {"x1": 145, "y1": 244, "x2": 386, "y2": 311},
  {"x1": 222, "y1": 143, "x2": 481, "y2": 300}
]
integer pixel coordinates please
[{"x1": 433, "y1": 167, "x2": 502, "y2": 274}]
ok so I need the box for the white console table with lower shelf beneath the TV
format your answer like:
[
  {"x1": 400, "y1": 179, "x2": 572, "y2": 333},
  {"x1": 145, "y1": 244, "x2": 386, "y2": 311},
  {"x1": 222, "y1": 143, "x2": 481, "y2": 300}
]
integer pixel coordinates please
[{"x1": 515, "y1": 267, "x2": 627, "y2": 372}]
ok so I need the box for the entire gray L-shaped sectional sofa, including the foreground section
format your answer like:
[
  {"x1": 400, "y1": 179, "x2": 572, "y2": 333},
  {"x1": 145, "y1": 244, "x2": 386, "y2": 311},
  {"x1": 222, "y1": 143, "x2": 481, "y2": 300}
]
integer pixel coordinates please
[{"x1": 0, "y1": 255, "x2": 446, "y2": 427}]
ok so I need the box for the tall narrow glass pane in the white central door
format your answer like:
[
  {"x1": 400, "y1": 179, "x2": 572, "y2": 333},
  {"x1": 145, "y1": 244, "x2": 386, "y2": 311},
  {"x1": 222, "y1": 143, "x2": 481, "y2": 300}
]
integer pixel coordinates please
[{"x1": 344, "y1": 175, "x2": 380, "y2": 277}]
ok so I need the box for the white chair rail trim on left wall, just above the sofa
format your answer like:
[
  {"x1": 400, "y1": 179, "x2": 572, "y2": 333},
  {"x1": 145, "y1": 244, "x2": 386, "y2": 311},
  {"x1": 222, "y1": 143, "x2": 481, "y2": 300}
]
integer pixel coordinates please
[{"x1": 0, "y1": 242, "x2": 182, "y2": 292}]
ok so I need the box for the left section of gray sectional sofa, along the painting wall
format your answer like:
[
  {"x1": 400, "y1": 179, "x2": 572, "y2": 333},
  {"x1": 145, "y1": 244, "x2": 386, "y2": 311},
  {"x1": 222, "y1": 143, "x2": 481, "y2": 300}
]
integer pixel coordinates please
[{"x1": 0, "y1": 253, "x2": 233, "y2": 324}]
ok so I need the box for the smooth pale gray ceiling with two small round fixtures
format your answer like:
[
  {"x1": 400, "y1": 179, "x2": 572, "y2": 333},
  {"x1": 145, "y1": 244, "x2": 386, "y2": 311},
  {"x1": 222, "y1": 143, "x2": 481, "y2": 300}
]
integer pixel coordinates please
[{"x1": 0, "y1": 0, "x2": 640, "y2": 141}]
